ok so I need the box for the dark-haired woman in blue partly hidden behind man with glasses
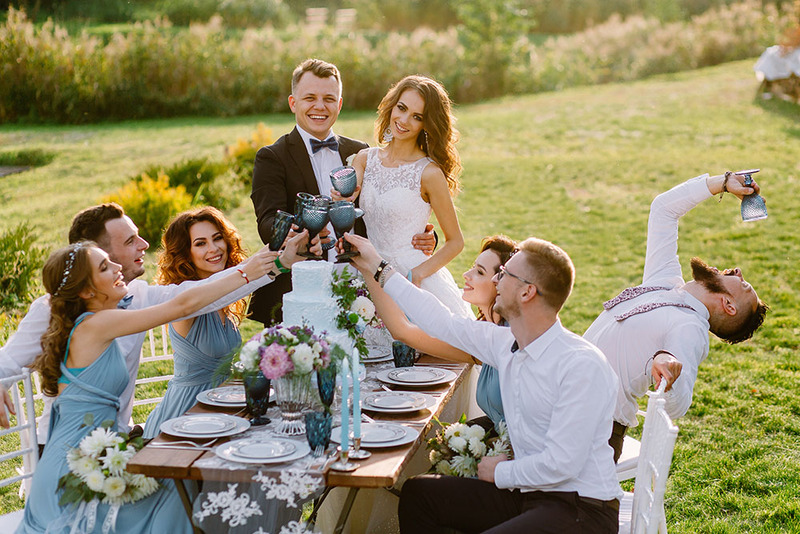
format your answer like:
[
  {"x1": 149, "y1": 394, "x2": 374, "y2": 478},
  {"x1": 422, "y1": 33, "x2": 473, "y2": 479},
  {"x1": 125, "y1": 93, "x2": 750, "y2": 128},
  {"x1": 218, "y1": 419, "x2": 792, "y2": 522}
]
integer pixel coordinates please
[{"x1": 367, "y1": 235, "x2": 516, "y2": 430}]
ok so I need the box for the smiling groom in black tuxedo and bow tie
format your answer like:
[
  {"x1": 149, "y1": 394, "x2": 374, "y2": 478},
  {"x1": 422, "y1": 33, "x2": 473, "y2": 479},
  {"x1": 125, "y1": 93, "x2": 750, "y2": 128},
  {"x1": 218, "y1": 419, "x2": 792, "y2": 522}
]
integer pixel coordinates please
[{"x1": 250, "y1": 59, "x2": 434, "y2": 325}]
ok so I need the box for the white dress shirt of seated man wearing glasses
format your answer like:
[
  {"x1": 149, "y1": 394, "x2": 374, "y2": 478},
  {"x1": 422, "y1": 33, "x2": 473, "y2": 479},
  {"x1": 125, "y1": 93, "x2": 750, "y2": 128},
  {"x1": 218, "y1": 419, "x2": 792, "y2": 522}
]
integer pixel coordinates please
[{"x1": 385, "y1": 275, "x2": 622, "y2": 500}]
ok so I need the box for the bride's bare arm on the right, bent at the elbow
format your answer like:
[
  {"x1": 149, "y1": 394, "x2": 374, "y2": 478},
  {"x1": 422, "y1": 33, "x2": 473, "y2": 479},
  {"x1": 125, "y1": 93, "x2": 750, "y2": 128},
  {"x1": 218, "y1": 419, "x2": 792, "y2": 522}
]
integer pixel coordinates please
[{"x1": 412, "y1": 164, "x2": 464, "y2": 286}]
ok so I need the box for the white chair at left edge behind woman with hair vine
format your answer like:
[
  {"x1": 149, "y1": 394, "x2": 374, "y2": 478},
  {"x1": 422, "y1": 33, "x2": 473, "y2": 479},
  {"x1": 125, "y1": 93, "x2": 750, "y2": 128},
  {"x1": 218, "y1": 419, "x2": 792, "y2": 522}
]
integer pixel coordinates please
[{"x1": 0, "y1": 368, "x2": 39, "y2": 532}]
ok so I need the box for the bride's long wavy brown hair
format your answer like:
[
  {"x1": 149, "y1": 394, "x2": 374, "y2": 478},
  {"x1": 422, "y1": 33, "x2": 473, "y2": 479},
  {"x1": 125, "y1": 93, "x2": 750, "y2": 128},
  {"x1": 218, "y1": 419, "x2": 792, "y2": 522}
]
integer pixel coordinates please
[{"x1": 375, "y1": 75, "x2": 461, "y2": 196}]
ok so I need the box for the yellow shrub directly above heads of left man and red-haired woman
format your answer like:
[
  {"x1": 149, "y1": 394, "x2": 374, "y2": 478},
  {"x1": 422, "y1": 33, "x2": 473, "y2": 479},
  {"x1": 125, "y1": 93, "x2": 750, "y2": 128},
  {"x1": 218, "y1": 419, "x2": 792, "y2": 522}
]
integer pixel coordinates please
[{"x1": 101, "y1": 174, "x2": 192, "y2": 243}]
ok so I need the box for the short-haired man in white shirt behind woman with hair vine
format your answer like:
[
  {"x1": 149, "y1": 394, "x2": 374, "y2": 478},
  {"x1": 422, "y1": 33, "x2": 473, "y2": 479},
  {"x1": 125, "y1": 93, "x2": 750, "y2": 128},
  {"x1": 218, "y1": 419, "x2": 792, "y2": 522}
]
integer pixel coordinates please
[{"x1": 0, "y1": 203, "x2": 282, "y2": 444}]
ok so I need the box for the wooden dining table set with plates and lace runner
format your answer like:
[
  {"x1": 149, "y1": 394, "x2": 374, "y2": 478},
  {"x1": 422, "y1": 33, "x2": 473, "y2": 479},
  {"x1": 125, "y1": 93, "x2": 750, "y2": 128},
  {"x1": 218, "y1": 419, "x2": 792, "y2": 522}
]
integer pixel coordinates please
[{"x1": 128, "y1": 356, "x2": 472, "y2": 532}]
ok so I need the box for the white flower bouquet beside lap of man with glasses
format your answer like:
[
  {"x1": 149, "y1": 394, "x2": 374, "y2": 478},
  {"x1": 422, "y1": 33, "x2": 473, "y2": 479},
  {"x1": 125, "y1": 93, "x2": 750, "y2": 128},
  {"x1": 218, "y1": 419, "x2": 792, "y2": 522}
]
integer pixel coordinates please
[{"x1": 428, "y1": 415, "x2": 513, "y2": 478}]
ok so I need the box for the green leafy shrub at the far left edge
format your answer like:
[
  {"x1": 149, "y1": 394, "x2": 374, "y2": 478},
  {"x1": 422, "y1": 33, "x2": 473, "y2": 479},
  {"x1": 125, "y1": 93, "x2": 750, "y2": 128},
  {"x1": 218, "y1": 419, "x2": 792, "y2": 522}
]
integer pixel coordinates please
[{"x1": 0, "y1": 223, "x2": 47, "y2": 310}]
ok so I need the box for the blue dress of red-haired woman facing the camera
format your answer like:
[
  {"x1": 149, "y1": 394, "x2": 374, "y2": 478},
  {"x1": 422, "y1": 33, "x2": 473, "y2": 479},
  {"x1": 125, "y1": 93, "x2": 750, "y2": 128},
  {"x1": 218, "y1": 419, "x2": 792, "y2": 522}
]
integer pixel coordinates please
[{"x1": 144, "y1": 312, "x2": 242, "y2": 438}]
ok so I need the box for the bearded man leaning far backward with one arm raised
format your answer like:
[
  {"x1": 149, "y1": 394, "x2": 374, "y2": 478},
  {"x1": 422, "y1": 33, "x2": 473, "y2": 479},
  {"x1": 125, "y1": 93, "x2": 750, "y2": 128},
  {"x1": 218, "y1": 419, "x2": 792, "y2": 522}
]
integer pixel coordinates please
[{"x1": 583, "y1": 172, "x2": 768, "y2": 461}]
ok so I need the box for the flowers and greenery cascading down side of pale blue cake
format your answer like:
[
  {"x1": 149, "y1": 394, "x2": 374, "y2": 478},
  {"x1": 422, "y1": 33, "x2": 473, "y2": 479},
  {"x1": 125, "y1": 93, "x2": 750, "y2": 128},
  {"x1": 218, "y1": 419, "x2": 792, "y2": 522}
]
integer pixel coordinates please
[{"x1": 331, "y1": 269, "x2": 383, "y2": 357}]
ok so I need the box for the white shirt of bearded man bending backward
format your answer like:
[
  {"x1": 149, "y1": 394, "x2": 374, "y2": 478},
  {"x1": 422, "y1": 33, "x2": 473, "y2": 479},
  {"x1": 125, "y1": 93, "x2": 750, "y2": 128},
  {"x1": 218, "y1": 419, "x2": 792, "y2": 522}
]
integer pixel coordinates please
[{"x1": 583, "y1": 174, "x2": 711, "y2": 427}]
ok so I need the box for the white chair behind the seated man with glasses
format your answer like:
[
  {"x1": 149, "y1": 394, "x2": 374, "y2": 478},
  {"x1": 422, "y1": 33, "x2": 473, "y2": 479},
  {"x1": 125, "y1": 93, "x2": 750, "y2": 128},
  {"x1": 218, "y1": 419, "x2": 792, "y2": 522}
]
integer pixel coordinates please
[{"x1": 619, "y1": 382, "x2": 678, "y2": 534}]
